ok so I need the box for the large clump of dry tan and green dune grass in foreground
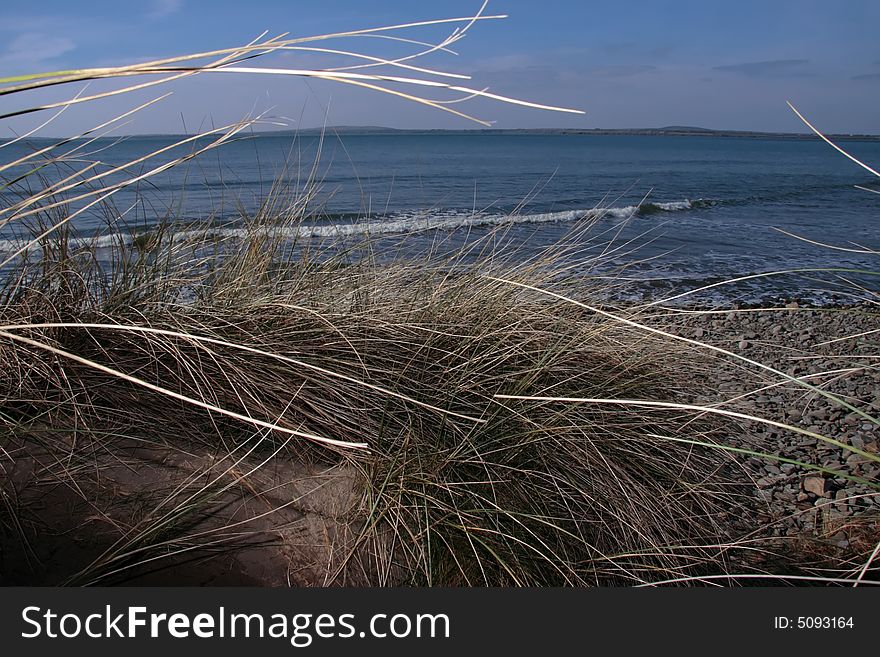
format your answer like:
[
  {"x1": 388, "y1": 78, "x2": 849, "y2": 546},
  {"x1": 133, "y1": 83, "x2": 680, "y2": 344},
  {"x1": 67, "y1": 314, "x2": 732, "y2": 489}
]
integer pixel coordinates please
[{"x1": 0, "y1": 205, "x2": 743, "y2": 585}]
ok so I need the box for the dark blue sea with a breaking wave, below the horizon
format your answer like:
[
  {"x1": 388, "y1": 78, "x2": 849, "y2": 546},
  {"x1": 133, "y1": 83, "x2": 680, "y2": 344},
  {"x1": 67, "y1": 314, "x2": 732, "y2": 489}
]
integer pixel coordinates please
[{"x1": 0, "y1": 132, "x2": 880, "y2": 303}]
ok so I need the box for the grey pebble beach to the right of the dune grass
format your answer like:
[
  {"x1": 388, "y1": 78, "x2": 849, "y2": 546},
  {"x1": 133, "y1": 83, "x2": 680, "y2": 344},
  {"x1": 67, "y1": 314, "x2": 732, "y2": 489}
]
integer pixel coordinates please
[{"x1": 667, "y1": 302, "x2": 880, "y2": 550}]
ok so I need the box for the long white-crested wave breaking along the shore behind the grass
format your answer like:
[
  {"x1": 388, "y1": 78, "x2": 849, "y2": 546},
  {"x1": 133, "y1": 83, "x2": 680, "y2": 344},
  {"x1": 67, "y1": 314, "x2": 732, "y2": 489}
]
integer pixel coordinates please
[{"x1": 0, "y1": 199, "x2": 709, "y2": 253}]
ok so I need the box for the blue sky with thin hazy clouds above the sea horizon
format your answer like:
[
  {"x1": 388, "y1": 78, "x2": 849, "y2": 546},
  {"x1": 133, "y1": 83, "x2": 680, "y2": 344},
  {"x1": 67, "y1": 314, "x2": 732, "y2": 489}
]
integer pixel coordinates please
[{"x1": 0, "y1": 0, "x2": 880, "y2": 136}]
